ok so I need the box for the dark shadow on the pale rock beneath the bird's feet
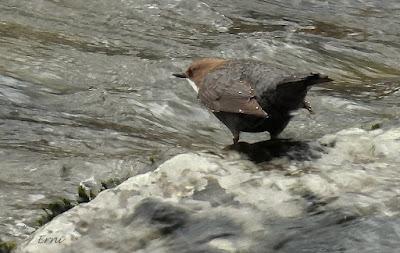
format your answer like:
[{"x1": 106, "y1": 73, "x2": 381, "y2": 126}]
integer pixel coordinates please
[{"x1": 224, "y1": 139, "x2": 319, "y2": 163}]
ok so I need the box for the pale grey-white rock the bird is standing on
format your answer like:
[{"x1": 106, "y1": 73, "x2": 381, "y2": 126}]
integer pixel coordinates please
[{"x1": 17, "y1": 129, "x2": 400, "y2": 253}]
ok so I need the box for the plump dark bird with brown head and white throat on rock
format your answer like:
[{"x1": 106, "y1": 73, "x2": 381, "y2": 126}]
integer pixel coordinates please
[{"x1": 173, "y1": 58, "x2": 333, "y2": 144}]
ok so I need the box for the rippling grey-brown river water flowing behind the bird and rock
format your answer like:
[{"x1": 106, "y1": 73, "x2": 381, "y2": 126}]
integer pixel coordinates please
[{"x1": 0, "y1": 0, "x2": 400, "y2": 252}]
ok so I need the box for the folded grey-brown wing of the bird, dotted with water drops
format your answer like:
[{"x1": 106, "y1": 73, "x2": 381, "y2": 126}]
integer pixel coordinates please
[{"x1": 198, "y1": 77, "x2": 268, "y2": 117}]
